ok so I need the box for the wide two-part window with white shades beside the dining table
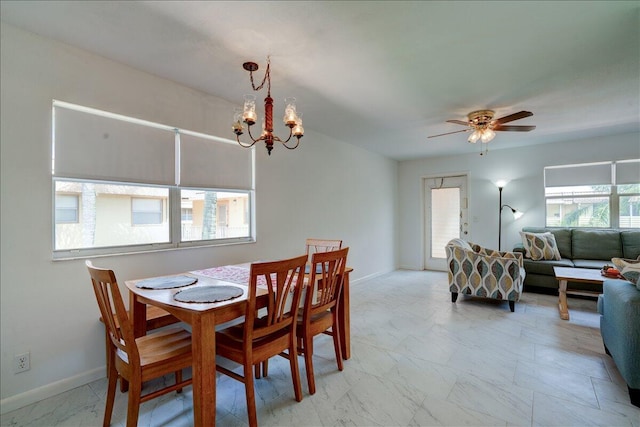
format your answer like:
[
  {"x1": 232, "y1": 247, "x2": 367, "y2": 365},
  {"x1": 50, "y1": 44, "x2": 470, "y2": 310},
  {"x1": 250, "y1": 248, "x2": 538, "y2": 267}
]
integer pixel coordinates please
[{"x1": 52, "y1": 101, "x2": 255, "y2": 258}]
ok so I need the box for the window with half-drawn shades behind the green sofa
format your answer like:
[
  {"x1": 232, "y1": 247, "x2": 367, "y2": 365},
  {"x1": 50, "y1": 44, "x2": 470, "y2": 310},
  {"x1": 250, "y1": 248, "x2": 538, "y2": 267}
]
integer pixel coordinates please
[{"x1": 544, "y1": 160, "x2": 640, "y2": 228}]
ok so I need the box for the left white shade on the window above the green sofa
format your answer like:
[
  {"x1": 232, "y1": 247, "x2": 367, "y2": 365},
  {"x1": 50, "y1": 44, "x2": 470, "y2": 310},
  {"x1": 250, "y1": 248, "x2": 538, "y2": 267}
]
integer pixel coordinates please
[{"x1": 544, "y1": 162, "x2": 613, "y2": 187}]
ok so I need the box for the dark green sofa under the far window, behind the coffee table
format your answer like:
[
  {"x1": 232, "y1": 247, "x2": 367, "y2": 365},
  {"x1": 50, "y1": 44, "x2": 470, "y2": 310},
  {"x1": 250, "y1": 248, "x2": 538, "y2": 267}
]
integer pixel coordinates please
[{"x1": 514, "y1": 227, "x2": 640, "y2": 291}]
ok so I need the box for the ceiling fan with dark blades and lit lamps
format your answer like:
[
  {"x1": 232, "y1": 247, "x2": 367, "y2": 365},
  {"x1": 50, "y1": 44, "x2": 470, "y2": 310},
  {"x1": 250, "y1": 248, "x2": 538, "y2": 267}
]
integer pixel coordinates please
[{"x1": 428, "y1": 110, "x2": 536, "y2": 144}]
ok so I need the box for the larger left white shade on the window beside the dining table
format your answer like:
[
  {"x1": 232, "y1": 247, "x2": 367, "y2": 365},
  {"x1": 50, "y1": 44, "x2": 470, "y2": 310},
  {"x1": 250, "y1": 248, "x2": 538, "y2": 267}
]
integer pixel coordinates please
[{"x1": 54, "y1": 106, "x2": 175, "y2": 185}]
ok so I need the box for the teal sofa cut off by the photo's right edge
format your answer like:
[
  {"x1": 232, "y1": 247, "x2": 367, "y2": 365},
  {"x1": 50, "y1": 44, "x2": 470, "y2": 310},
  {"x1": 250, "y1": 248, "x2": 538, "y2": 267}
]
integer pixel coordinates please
[{"x1": 598, "y1": 280, "x2": 640, "y2": 407}]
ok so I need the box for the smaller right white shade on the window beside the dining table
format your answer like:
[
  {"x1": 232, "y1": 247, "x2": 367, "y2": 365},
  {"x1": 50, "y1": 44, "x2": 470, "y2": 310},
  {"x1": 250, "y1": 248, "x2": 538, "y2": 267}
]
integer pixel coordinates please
[{"x1": 180, "y1": 133, "x2": 253, "y2": 190}]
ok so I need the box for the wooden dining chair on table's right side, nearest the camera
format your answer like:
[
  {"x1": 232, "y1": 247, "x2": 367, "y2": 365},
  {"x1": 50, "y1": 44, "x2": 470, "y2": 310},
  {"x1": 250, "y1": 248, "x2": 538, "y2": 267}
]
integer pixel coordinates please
[{"x1": 216, "y1": 255, "x2": 307, "y2": 427}]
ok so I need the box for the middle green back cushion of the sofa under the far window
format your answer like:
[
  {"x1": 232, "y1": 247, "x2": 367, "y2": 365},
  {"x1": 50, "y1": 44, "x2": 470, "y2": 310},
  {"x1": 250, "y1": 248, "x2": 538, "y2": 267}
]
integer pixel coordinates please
[{"x1": 571, "y1": 228, "x2": 622, "y2": 260}]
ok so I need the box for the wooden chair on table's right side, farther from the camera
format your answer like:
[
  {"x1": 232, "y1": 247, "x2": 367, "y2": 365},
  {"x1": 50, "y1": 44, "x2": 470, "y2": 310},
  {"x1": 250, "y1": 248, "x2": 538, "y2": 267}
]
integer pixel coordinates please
[{"x1": 297, "y1": 248, "x2": 349, "y2": 394}]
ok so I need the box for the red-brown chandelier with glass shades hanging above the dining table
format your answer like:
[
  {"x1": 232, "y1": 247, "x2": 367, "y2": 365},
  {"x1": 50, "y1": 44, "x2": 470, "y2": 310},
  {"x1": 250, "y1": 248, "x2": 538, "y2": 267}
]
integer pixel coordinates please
[{"x1": 233, "y1": 58, "x2": 304, "y2": 155}]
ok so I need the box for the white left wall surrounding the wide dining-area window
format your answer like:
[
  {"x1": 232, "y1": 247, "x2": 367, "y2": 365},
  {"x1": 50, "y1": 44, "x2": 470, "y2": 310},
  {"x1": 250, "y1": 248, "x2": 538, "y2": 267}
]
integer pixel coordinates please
[{"x1": 0, "y1": 23, "x2": 398, "y2": 413}]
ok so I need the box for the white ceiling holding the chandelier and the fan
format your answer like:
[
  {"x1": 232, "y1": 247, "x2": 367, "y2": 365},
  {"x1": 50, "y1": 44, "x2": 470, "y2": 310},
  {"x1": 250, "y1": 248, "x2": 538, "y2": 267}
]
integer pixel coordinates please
[{"x1": 0, "y1": 0, "x2": 640, "y2": 160}]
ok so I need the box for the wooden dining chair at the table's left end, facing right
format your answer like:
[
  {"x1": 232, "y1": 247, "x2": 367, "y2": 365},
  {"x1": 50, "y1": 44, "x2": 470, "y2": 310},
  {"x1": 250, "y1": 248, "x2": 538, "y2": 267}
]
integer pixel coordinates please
[{"x1": 86, "y1": 261, "x2": 192, "y2": 427}]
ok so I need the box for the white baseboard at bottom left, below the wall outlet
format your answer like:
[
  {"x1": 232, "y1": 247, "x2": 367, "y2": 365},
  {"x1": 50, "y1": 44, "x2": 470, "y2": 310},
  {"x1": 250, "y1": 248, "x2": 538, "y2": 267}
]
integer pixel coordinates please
[{"x1": 0, "y1": 366, "x2": 106, "y2": 415}]
